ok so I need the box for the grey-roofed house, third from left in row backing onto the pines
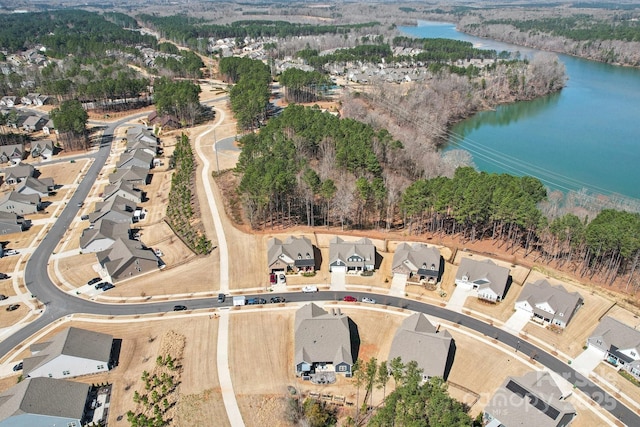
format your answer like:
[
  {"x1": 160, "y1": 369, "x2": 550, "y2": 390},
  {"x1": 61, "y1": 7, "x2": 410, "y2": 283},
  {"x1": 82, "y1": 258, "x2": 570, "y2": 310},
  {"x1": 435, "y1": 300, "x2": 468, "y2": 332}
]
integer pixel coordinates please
[{"x1": 391, "y1": 243, "x2": 442, "y2": 283}]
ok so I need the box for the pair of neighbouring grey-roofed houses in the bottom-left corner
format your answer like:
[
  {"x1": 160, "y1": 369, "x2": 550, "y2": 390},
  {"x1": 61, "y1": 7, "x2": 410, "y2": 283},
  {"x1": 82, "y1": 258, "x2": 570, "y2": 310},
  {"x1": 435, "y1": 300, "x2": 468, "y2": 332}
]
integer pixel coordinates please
[{"x1": 0, "y1": 327, "x2": 116, "y2": 427}]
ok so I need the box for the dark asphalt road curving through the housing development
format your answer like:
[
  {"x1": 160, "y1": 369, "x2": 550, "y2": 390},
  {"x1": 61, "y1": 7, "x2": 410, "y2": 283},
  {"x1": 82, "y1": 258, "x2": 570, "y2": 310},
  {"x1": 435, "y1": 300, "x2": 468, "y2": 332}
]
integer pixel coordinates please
[{"x1": 0, "y1": 113, "x2": 640, "y2": 426}]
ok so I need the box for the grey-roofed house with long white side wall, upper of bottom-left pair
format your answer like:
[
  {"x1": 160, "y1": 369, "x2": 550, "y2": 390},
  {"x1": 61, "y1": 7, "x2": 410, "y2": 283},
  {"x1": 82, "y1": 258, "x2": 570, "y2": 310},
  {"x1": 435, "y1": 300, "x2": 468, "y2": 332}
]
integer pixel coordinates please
[{"x1": 22, "y1": 327, "x2": 113, "y2": 378}]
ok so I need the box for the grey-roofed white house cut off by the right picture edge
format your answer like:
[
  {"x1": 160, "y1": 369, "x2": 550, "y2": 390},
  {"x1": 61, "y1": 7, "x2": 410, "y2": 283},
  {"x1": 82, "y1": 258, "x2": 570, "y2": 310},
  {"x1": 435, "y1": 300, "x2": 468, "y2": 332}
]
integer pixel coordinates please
[{"x1": 587, "y1": 316, "x2": 640, "y2": 379}]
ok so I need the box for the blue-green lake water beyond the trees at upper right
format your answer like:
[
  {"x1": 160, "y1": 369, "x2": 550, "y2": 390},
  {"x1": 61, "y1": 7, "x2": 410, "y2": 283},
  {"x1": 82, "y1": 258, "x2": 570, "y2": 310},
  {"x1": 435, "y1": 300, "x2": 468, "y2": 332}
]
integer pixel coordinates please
[{"x1": 401, "y1": 22, "x2": 640, "y2": 199}]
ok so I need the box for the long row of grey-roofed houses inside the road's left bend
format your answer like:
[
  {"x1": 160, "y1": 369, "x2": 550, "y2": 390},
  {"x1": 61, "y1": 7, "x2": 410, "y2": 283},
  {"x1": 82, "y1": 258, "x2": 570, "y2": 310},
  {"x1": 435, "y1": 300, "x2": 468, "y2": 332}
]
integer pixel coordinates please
[{"x1": 80, "y1": 127, "x2": 164, "y2": 282}]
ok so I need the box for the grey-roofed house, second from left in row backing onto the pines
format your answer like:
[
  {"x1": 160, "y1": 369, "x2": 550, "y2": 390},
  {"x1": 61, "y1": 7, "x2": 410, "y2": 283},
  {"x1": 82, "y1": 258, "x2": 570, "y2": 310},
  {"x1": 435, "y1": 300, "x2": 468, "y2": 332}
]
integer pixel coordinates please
[{"x1": 329, "y1": 237, "x2": 376, "y2": 272}]
